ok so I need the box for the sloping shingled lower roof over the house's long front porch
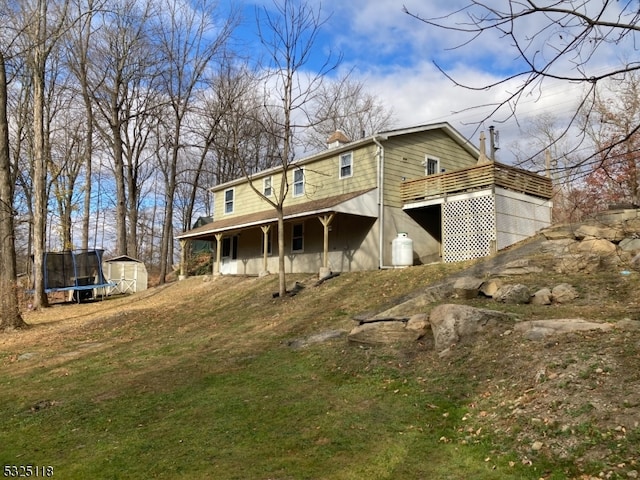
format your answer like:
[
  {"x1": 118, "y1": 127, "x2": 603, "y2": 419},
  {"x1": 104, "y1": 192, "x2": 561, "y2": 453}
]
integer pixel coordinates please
[{"x1": 176, "y1": 188, "x2": 377, "y2": 240}]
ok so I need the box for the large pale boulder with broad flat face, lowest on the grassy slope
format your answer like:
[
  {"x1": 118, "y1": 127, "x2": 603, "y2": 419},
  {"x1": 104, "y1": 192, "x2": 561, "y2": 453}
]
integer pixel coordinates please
[{"x1": 429, "y1": 304, "x2": 514, "y2": 351}]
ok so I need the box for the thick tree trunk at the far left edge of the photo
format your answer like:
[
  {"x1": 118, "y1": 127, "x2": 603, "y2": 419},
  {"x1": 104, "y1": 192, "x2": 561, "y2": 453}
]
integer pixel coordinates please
[{"x1": 0, "y1": 52, "x2": 27, "y2": 331}]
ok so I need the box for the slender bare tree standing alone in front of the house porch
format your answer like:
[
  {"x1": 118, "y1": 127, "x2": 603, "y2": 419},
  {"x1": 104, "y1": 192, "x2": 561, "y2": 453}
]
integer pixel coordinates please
[{"x1": 250, "y1": 0, "x2": 340, "y2": 297}]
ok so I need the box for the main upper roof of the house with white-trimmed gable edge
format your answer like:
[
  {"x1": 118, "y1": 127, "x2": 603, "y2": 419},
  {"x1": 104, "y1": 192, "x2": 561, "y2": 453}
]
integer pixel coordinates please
[{"x1": 209, "y1": 122, "x2": 480, "y2": 192}]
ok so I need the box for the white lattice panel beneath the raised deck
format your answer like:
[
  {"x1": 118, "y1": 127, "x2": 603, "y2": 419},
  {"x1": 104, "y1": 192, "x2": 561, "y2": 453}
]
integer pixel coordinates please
[{"x1": 442, "y1": 195, "x2": 496, "y2": 262}]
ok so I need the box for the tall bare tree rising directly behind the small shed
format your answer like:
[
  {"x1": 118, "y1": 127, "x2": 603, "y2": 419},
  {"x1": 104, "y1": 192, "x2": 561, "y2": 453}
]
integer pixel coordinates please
[{"x1": 89, "y1": 0, "x2": 157, "y2": 255}]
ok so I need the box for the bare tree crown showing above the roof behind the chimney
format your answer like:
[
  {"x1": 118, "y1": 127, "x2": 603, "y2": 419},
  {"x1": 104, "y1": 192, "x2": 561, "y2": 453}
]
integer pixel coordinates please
[{"x1": 305, "y1": 77, "x2": 393, "y2": 150}]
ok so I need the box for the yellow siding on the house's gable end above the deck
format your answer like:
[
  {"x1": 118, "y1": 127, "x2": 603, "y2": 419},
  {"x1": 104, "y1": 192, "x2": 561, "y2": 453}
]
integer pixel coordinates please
[{"x1": 384, "y1": 130, "x2": 477, "y2": 207}]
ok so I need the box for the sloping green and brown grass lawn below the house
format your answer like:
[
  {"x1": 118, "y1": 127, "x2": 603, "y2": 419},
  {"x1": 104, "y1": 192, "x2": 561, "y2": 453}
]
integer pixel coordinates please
[{"x1": 0, "y1": 265, "x2": 632, "y2": 480}]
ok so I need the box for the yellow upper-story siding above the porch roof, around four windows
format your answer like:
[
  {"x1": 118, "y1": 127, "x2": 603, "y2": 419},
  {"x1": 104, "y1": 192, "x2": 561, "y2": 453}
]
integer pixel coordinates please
[{"x1": 214, "y1": 144, "x2": 377, "y2": 220}]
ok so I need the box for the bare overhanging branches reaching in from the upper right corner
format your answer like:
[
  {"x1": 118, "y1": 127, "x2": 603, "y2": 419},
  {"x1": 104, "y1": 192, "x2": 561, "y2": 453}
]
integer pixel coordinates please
[{"x1": 404, "y1": 0, "x2": 640, "y2": 172}]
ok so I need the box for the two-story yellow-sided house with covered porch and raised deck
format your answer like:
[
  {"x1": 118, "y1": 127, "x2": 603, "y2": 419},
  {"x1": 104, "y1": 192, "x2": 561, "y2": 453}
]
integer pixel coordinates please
[{"x1": 177, "y1": 123, "x2": 551, "y2": 275}]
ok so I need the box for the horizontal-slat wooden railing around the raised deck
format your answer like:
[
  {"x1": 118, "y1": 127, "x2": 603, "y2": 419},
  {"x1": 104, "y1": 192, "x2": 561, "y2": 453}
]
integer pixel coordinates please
[{"x1": 400, "y1": 162, "x2": 553, "y2": 203}]
